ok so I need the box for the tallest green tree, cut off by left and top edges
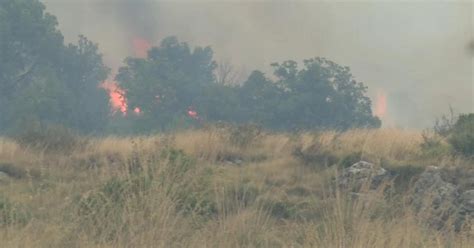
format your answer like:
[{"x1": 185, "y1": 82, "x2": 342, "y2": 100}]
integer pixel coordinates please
[{"x1": 0, "y1": 0, "x2": 63, "y2": 129}]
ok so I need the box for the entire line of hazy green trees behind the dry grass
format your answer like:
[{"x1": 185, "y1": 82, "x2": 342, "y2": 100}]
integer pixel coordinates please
[{"x1": 0, "y1": 0, "x2": 380, "y2": 134}]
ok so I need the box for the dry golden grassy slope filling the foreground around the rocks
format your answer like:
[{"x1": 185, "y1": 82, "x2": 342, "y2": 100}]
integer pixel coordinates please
[{"x1": 0, "y1": 127, "x2": 474, "y2": 247}]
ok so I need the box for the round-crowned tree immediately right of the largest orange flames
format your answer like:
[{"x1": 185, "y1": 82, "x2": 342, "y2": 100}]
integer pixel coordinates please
[{"x1": 116, "y1": 37, "x2": 216, "y2": 129}]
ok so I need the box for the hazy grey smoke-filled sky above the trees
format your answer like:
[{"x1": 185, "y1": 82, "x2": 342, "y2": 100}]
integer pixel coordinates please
[{"x1": 43, "y1": 0, "x2": 474, "y2": 127}]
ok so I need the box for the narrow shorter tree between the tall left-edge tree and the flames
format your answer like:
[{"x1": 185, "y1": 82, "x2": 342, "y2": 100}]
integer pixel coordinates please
[{"x1": 58, "y1": 36, "x2": 110, "y2": 132}]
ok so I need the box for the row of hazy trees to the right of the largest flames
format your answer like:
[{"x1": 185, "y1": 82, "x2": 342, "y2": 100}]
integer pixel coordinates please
[{"x1": 116, "y1": 37, "x2": 380, "y2": 131}]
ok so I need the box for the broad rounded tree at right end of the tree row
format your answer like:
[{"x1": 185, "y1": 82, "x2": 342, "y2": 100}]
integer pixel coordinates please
[{"x1": 269, "y1": 58, "x2": 380, "y2": 129}]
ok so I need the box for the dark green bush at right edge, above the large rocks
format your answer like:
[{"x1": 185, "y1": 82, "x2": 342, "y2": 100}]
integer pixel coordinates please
[{"x1": 448, "y1": 113, "x2": 474, "y2": 157}]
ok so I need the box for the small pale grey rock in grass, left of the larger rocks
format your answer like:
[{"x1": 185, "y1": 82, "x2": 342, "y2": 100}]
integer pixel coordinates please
[{"x1": 337, "y1": 161, "x2": 390, "y2": 191}]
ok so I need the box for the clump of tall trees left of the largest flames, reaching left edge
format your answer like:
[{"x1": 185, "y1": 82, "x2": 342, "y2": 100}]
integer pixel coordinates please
[{"x1": 0, "y1": 0, "x2": 108, "y2": 132}]
